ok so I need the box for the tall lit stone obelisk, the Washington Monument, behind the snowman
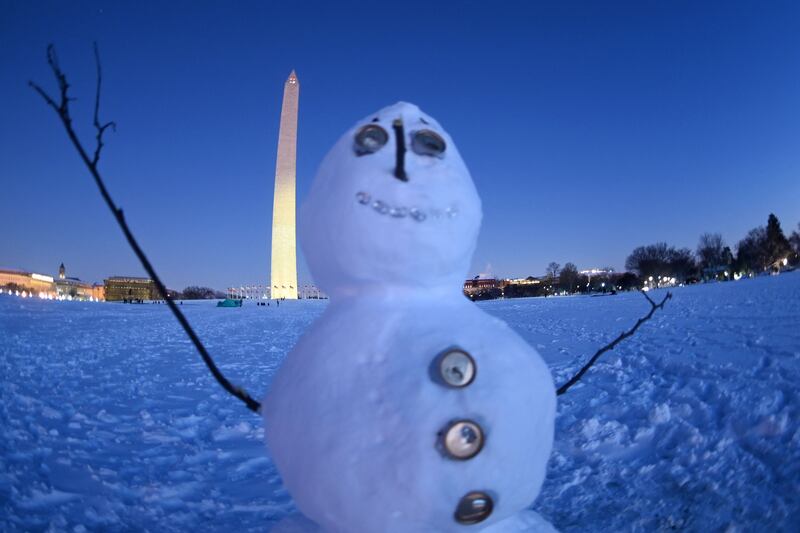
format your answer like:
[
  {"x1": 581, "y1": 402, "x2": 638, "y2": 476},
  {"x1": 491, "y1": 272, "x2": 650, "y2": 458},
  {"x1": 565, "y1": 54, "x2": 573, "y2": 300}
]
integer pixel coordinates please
[{"x1": 270, "y1": 70, "x2": 300, "y2": 300}]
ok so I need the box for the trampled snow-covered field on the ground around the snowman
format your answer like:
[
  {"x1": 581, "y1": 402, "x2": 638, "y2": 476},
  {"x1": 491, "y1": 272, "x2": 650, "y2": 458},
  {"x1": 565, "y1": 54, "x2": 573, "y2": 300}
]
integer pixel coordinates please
[{"x1": 0, "y1": 273, "x2": 800, "y2": 531}]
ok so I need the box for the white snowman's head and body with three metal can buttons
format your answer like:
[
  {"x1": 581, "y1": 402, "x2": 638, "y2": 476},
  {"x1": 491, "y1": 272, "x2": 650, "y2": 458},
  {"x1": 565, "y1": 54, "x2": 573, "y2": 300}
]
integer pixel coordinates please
[{"x1": 262, "y1": 102, "x2": 556, "y2": 533}]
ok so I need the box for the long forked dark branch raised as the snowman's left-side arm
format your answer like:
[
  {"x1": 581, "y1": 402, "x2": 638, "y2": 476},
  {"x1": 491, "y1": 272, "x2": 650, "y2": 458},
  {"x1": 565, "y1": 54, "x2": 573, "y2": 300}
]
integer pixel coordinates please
[{"x1": 28, "y1": 43, "x2": 261, "y2": 413}]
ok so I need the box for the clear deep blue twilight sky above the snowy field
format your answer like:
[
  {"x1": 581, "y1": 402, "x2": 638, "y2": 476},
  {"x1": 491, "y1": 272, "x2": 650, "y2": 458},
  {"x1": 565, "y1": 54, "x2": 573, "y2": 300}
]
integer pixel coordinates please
[{"x1": 0, "y1": 0, "x2": 800, "y2": 289}]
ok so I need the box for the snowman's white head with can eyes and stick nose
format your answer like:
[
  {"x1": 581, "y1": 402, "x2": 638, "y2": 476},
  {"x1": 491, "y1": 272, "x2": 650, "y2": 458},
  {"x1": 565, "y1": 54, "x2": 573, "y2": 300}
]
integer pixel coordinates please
[{"x1": 299, "y1": 102, "x2": 481, "y2": 295}]
